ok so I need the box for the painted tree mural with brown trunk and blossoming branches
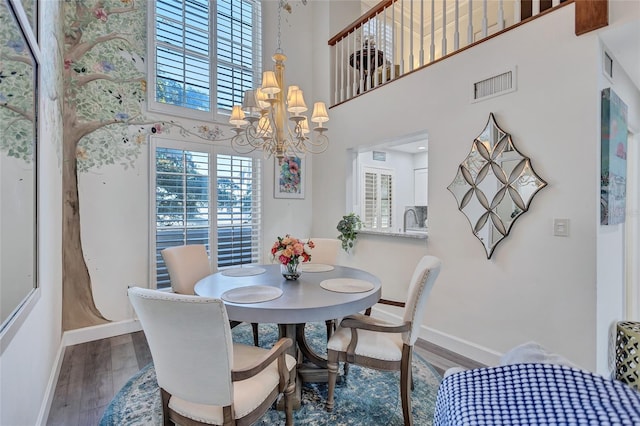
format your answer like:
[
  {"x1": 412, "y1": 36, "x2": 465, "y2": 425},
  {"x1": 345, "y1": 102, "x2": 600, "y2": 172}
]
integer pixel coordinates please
[{"x1": 62, "y1": 0, "x2": 222, "y2": 330}]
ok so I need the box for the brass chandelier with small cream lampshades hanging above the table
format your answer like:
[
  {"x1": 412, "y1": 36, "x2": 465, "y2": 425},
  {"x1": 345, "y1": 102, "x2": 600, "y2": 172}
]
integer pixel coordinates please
[{"x1": 229, "y1": 3, "x2": 329, "y2": 158}]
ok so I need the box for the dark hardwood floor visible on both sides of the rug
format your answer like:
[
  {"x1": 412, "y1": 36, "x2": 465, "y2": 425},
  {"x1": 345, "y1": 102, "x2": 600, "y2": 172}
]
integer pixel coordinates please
[{"x1": 47, "y1": 331, "x2": 482, "y2": 426}]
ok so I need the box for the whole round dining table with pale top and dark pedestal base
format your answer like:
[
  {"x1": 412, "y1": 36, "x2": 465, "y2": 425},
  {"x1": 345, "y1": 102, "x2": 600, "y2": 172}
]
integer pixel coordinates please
[{"x1": 194, "y1": 264, "x2": 381, "y2": 409}]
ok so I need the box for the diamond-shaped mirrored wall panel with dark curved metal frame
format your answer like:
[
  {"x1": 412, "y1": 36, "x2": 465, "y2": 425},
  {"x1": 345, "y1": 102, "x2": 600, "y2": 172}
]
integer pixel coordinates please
[{"x1": 447, "y1": 114, "x2": 547, "y2": 259}]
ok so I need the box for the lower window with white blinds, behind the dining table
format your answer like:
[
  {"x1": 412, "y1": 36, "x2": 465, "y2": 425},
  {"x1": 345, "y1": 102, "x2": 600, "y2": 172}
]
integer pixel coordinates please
[{"x1": 152, "y1": 139, "x2": 261, "y2": 288}]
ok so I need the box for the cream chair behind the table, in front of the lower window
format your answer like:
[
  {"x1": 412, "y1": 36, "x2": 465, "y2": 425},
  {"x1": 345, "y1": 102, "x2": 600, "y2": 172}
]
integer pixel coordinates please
[{"x1": 160, "y1": 244, "x2": 260, "y2": 346}]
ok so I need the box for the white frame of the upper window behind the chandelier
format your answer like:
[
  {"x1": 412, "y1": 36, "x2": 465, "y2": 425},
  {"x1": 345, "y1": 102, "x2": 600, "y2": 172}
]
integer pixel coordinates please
[{"x1": 146, "y1": 0, "x2": 262, "y2": 124}]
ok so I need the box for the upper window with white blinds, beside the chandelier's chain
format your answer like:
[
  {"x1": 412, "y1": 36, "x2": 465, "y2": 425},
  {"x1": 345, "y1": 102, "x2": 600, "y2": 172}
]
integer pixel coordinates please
[{"x1": 149, "y1": 0, "x2": 261, "y2": 119}]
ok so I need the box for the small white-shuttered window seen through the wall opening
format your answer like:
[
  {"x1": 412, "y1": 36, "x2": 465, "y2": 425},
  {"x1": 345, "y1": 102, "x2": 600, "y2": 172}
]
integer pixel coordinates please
[{"x1": 361, "y1": 167, "x2": 393, "y2": 230}]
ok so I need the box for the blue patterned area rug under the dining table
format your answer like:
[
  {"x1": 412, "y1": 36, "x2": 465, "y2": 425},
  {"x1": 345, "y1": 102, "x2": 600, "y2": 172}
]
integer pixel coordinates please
[{"x1": 100, "y1": 323, "x2": 442, "y2": 426}]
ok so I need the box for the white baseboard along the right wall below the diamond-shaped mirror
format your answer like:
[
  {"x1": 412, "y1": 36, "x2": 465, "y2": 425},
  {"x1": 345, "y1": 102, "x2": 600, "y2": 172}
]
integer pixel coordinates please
[{"x1": 373, "y1": 307, "x2": 502, "y2": 365}]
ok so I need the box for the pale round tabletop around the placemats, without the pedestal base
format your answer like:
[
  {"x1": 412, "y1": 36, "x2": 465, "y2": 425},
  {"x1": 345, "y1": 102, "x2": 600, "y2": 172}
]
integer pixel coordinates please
[{"x1": 194, "y1": 264, "x2": 381, "y2": 324}]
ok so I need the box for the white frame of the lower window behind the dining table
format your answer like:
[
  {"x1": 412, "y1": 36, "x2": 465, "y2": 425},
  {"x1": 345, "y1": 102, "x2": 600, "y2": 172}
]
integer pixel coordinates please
[{"x1": 149, "y1": 136, "x2": 264, "y2": 289}]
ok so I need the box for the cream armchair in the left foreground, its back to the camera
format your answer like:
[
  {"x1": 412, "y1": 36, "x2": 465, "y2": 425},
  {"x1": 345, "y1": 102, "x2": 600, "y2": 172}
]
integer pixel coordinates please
[{"x1": 129, "y1": 287, "x2": 296, "y2": 426}]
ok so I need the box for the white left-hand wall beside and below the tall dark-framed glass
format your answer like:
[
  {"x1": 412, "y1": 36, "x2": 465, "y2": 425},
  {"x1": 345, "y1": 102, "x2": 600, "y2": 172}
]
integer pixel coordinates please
[{"x1": 0, "y1": 2, "x2": 62, "y2": 425}]
